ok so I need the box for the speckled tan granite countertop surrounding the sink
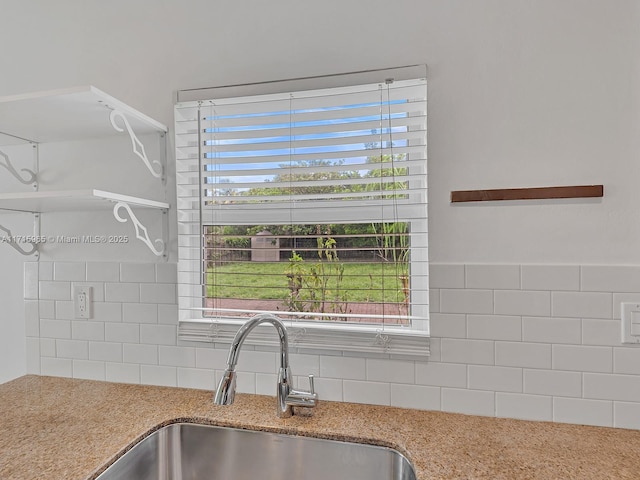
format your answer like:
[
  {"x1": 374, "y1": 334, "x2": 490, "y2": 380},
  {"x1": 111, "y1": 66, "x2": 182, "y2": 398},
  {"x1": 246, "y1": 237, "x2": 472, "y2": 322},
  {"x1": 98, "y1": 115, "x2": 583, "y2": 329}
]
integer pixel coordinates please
[{"x1": 0, "y1": 375, "x2": 640, "y2": 480}]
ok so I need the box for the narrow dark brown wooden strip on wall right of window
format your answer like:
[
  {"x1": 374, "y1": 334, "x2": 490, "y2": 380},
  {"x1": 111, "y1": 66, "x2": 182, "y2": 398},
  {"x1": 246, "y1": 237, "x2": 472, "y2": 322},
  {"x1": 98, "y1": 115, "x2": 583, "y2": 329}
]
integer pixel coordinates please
[{"x1": 451, "y1": 185, "x2": 604, "y2": 203}]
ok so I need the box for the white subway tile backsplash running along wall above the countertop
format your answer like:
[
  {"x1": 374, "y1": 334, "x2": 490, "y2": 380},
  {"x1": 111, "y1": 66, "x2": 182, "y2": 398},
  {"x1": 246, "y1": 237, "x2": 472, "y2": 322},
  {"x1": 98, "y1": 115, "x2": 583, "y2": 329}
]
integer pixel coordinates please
[{"x1": 24, "y1": 261, "x2": 640, "y2": 429}]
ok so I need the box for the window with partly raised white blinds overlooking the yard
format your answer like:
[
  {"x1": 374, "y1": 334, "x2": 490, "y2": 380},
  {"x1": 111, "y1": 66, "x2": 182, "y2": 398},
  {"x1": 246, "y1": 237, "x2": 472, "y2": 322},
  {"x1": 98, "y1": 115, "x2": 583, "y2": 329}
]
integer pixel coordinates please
[{"x1": 175, "y1": 67, "x2": 428, "y2": 355}]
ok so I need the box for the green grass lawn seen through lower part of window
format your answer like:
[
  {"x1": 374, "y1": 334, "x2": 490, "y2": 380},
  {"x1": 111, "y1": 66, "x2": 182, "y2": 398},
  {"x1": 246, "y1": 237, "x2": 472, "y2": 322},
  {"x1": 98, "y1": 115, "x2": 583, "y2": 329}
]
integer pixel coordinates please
[{"x1": 207, "y1": 262, "x2": 404, "y2": 303}]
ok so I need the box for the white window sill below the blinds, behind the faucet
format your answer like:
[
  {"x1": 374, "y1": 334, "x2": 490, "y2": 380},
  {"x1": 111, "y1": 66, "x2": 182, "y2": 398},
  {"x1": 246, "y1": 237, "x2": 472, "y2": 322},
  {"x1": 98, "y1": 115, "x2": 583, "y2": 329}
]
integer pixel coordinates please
[{"x1": 178, "y1": 318, "x2": 429, "y2": 360}]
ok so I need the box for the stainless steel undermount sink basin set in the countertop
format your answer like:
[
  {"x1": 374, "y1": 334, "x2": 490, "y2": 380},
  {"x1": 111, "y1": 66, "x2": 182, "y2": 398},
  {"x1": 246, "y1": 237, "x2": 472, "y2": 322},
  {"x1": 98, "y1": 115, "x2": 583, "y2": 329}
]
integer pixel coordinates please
[{"x1": 97, "y1": 423, "x2": 416, "y2": 480}]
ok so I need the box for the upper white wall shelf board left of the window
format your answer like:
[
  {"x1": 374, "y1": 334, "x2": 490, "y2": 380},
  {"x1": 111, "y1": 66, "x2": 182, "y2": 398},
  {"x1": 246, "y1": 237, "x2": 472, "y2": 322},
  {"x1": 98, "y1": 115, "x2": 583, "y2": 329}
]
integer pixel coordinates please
[{"x1": 0, "y1": 86, "x2": 167, "y2": 144}]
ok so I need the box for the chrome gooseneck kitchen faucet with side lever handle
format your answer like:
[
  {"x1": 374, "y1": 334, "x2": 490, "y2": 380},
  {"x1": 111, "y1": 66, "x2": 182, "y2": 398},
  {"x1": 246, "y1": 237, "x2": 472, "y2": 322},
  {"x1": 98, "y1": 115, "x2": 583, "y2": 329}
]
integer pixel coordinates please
[{"x1": 213, "y1": 313, "x2": 318, "y2": 418}]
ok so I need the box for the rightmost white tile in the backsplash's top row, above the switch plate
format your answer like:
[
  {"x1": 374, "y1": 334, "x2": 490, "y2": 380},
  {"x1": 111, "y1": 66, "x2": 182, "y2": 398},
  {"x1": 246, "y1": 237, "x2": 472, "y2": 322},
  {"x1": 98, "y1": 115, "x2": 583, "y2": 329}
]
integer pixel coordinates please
[{"x1": 580, "y1": 265, "x2": 640, "y2": 293}]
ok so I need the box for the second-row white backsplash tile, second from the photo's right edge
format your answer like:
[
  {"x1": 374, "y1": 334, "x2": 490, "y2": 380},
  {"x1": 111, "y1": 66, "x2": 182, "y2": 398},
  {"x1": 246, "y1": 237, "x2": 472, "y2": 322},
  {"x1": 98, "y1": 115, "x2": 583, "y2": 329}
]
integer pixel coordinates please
[{"x1": 551, "y1": 292, "x2": 613, "y2": 318}]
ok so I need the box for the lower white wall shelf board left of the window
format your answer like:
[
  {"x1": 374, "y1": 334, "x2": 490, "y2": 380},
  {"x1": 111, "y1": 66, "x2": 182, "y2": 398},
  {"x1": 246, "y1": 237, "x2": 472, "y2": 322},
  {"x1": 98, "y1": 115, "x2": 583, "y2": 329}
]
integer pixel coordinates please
[{"x1": 0, "y1": 189, "x2": 169, "y2": 213}]
